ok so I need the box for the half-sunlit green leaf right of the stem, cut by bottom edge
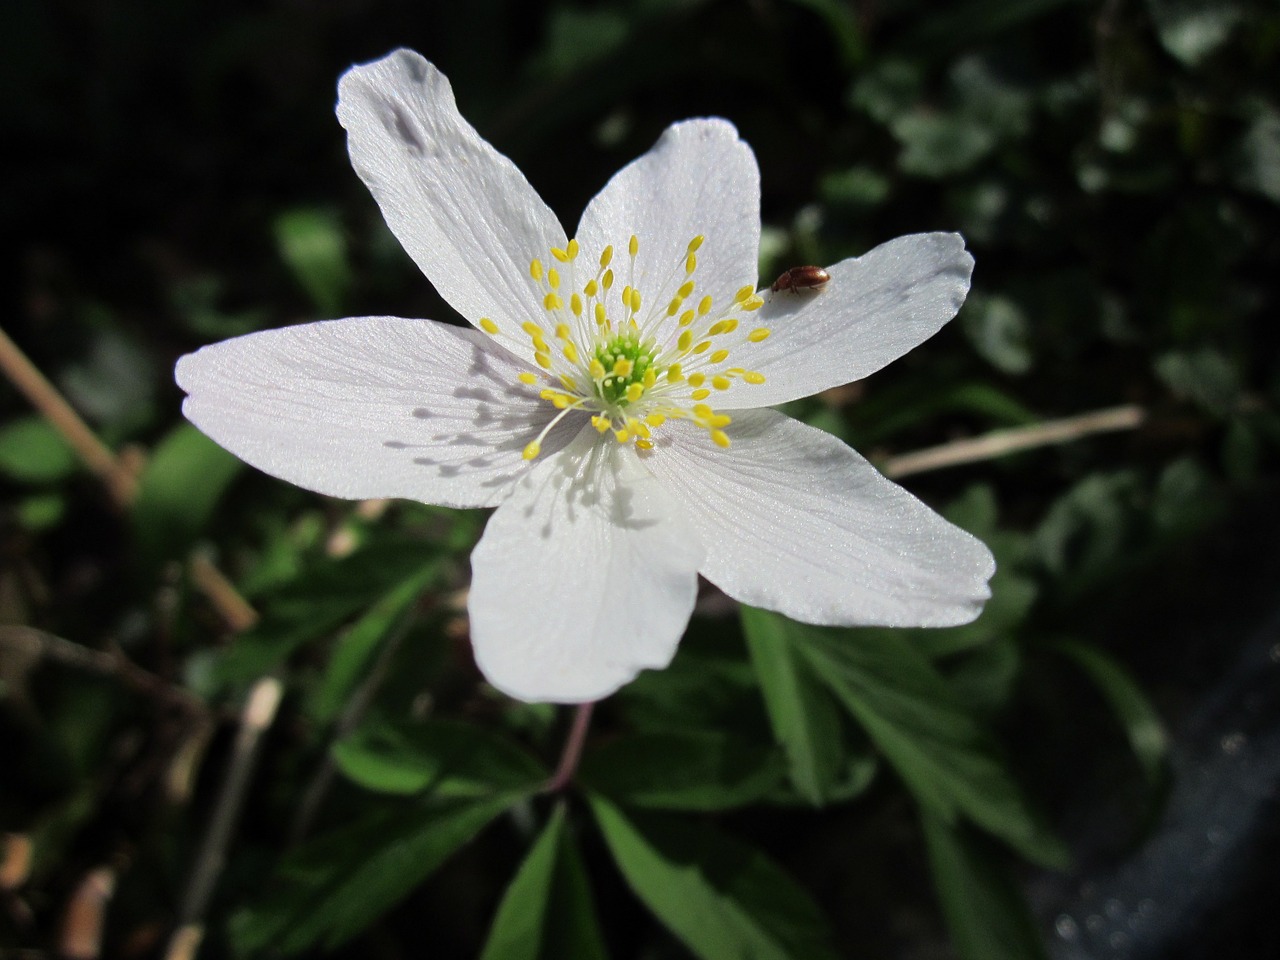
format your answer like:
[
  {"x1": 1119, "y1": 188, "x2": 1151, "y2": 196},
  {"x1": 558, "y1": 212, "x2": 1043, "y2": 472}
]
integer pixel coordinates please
[{"x1": 590, "y1": 795, "x2": 836, "y2": 960}]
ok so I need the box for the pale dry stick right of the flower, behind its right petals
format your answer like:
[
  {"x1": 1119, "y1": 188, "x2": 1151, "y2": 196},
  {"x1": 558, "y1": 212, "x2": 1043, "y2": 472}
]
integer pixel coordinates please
[{"x1": 881, "y1": 403, "x2": 1147, "y2": 480}]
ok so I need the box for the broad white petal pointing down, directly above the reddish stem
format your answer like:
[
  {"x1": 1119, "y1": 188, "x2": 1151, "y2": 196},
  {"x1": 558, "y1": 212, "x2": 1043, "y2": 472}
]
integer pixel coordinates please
[{"x1": 467, "y1": 426, "x2": 703, "y2": 703}]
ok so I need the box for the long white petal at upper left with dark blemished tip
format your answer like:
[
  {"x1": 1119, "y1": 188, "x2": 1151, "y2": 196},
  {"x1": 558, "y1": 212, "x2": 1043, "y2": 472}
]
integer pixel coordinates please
[{"x1": 338, "y1": 50, "x2": 564, "y2": 343}]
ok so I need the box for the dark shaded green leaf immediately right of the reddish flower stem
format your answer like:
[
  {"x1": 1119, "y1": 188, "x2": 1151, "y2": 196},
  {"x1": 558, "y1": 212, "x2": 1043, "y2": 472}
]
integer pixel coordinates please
[{"x1": 581, "y1": 731, "x2": 785, "y2": 810}]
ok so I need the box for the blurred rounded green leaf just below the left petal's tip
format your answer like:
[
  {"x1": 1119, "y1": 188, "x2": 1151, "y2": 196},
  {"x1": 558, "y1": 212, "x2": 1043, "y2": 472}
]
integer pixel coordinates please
[{"x1": 133, "y1": 424, "x2": 244, "y2": 562}]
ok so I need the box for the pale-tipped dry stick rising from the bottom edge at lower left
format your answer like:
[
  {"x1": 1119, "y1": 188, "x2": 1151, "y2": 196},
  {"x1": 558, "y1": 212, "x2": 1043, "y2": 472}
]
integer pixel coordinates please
[{"x1": 165, "y1": 677, "x2": 284, "y2": 960}]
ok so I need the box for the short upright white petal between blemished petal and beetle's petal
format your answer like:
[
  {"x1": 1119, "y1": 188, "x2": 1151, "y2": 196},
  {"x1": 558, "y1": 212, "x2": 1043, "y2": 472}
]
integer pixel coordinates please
[{"x1": 577, "y1": 119, "x2": 760, "y2": 330}]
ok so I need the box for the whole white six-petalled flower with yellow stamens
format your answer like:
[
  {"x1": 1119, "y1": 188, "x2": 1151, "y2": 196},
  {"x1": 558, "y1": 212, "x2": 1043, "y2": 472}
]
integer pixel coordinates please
[{"x1": 177, "y1": 50, "x2": 995, "y2": 703}]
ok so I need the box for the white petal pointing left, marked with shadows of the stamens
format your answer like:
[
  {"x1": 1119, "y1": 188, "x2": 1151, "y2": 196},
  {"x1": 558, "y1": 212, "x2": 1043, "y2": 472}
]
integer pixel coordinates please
[{"x1": 175, "y1": 316, "x2": 581, "y2": 507}]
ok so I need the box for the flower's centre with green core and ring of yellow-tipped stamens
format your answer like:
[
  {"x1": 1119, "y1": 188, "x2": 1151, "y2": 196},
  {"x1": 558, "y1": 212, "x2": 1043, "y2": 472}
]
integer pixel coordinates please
[{"x1": 479, "y1": 236, "x2": 769, "y2": 460}]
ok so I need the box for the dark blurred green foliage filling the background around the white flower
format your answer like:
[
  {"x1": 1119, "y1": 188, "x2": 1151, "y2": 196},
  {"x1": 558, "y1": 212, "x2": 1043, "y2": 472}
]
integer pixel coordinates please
[{"x1": 0, "y1": 0, "x2": 1280, "y2": 960}]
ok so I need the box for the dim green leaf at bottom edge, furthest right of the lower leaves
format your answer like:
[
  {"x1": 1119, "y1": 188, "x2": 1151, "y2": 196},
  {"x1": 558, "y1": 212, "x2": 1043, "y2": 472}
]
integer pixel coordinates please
[{"x1": 923, "y1": 814, "x2": 1044, "y2": 960}]
